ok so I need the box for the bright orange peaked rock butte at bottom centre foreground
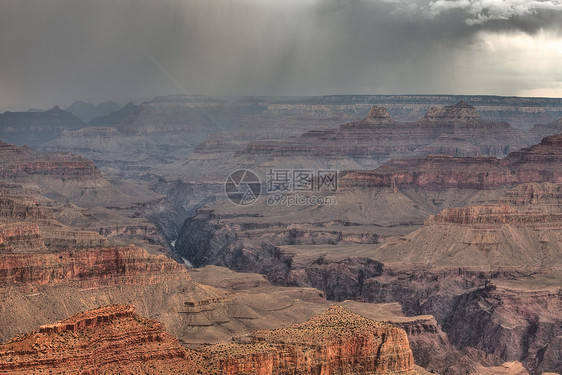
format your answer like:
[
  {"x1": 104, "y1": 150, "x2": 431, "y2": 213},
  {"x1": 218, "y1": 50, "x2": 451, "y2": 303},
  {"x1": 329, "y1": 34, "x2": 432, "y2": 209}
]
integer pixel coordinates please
[{"x1": 215, "y1": 306, "x2": 415, "y2": 375}]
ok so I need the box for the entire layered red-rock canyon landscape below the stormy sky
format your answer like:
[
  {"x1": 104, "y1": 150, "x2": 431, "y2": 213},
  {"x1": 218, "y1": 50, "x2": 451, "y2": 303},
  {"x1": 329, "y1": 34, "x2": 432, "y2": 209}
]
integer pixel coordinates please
[{"x1": 0, "y1": 96, "x2": 562, "y2": 374}]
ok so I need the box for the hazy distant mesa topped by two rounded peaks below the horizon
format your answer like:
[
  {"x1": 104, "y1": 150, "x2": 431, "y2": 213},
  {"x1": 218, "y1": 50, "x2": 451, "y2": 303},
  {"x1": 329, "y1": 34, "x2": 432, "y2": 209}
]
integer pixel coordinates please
[{"x1": 245, "y1": 101, "x2": 524, "y2": 161}]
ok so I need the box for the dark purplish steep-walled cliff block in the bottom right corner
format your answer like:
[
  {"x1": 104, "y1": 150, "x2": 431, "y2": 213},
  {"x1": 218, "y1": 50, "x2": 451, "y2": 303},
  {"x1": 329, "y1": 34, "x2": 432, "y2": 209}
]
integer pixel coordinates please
[{"x1": 444, "y1": 284, "x2": 562, "y2": 374}]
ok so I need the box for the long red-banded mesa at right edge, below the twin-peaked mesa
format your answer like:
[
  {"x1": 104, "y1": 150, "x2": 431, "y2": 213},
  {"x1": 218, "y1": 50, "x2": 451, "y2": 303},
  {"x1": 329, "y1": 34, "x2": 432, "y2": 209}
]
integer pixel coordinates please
[{"x1": 340, "y1": 134, "x2": 562, "y2": 190}]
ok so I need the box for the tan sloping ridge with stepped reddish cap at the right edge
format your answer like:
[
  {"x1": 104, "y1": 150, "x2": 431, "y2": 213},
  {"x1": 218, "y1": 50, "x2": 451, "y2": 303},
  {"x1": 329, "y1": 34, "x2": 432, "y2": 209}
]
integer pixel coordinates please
[{"x1": 364, "y1": 184, "x2": 562, "y2": 270}]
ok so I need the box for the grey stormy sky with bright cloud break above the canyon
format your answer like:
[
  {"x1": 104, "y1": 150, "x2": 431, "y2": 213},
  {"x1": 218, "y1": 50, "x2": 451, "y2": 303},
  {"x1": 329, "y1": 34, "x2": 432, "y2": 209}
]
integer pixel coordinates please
[{"x1": 0, "y1": 0, "x2": 562, "y2": 109}]
